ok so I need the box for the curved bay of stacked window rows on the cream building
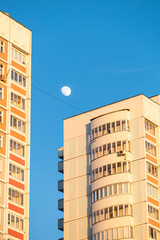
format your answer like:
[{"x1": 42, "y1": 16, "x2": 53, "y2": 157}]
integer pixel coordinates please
[{"x1": 91, "y1": 109, "x2": 134, "y2": 240}]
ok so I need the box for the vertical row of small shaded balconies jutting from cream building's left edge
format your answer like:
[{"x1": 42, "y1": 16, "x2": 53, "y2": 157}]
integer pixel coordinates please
[{"x1": 58, "y1": 147, "x2": 64, "y2": 240}]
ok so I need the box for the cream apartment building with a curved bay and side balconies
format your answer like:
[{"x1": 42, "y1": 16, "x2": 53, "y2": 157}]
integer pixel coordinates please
[{"x1": 58, "y1": 94, "x2": 160, "y2": 240}]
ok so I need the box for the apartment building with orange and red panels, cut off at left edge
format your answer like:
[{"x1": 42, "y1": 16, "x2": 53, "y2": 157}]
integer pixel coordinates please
[{"x1": 0, "y1": 11, "x2": 31, "y2": 240}]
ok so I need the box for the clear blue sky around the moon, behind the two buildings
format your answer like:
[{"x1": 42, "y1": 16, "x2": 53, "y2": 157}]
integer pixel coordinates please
[{"x1": 0, "y1": 0, "x2": 160, "y2": 240}]
